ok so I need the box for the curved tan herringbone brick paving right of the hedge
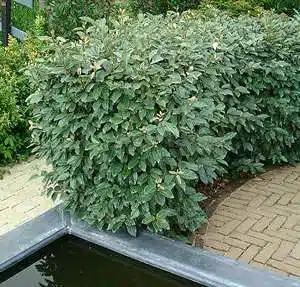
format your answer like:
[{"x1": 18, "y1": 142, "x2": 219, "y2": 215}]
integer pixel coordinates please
[{"x1": 202, "y1": 165, "x2": 300, "y2": 277}]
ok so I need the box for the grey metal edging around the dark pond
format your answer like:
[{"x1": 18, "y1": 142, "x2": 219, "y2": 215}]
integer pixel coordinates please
[{"x1": 0, "y1": 207, "x2": 300, "y2": 287}]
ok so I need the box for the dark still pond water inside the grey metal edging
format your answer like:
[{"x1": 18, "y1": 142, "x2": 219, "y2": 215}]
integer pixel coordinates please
[{"x1": 0, "y1": 237, "x2": 203, "y2": 287}]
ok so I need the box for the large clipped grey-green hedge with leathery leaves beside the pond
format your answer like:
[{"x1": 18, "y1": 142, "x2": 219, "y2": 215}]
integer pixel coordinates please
[{"x1": 28, "y1": 12, "x2": 300, "y2": 235}]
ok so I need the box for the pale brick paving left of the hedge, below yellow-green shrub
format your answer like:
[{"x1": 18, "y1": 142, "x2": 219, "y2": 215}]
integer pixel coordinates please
[{"x1": 0, "y1": 158, "x2": 54, "y2": 236}]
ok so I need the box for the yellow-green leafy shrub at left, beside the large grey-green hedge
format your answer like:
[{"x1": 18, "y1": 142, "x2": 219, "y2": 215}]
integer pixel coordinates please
[{"x1": 0, "y1": 18, "x2": 43, "y2": 164}]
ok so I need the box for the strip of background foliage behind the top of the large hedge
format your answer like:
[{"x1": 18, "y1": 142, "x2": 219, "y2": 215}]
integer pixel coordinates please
[{"x1": 12, "y1": 0, "x2": 300, "y2": 41}]
